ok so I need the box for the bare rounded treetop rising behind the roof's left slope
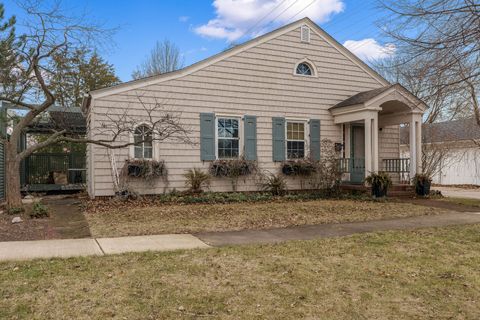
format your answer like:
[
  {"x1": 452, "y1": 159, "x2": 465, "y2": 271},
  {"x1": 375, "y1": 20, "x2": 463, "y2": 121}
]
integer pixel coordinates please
[{"x1": 132, "y1": 40, "x2": 183, "y2": 79}]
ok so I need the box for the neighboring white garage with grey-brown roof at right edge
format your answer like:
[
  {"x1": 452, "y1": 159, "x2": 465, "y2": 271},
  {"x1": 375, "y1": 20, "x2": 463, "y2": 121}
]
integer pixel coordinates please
[{"x1": 400, "y1": 118, "x2": 480, "y2": 185}]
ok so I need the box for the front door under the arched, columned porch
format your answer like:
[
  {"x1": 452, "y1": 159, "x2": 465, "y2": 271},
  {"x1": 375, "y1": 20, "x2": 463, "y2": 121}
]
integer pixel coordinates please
[{"x1": 350, "y1": 124, "x2": 365, "y2": 183}]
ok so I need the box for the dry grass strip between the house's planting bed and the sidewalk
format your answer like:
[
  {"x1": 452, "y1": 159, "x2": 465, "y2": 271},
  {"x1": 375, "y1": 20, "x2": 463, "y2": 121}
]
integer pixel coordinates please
[{"x1": 86, "y1": 200, "x2": 445, "y2": 237}]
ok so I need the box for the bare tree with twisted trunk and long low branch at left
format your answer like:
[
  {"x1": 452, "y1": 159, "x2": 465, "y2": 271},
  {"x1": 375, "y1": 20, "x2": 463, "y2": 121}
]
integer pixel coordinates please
[{"x1": 0, "y1": 0, "x2": 191, "y2": 209}]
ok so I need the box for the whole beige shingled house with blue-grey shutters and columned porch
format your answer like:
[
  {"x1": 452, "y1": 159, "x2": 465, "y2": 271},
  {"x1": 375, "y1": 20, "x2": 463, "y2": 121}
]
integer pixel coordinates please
[{"x1": 83, "y1": 18, "x2": 426, "y2": 197}]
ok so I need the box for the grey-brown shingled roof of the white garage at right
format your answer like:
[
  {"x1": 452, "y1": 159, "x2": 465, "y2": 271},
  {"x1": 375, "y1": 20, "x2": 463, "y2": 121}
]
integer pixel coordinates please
[{"x1": 400, "y1": 118, "x2": 480, "y2": 144}]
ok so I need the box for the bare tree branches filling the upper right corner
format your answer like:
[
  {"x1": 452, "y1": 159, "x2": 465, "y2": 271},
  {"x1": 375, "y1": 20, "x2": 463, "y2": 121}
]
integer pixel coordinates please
[{"x1": 380, "y1": 0, "x2": 480, "y2": 125}]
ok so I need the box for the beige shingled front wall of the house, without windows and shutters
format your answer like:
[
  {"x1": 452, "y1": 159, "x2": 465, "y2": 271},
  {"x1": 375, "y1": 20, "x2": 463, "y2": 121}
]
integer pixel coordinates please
[{"x1": 89, "y1": 27, "x2": 388, "y2": 196}]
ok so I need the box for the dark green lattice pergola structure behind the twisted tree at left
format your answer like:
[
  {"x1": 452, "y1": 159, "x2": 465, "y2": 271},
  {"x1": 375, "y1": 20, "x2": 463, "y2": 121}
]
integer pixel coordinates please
[{"x1": 0, "y1": 101, "x2": 86, "y2": 195}]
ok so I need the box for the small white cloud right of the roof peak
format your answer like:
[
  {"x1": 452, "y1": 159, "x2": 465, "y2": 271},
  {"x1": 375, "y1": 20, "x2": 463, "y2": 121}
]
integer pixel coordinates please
[{"x1": 343, "y1": 38, "x2": 396, "y2": 62}]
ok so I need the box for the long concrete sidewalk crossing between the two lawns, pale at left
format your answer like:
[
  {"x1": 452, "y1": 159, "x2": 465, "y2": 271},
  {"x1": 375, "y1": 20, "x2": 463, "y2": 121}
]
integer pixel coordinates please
[{"x1": 0, "y1": 212, "x2": 480, "y2": 261}]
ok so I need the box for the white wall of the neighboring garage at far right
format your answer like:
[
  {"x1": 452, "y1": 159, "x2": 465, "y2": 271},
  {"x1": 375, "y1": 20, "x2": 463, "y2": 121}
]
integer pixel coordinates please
[{"x1": 401, "y1": 142, "x2": 480, "y2": 185}]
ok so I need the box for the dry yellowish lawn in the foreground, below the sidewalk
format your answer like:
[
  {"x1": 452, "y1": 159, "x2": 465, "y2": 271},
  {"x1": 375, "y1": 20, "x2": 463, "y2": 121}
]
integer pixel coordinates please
[{"x1": 0, "y1": 225, "x2": 480, "y2": 319}]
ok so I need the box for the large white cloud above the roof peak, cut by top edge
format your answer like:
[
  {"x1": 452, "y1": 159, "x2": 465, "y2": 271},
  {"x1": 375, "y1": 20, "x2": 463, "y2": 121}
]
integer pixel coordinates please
[{"x1": 194, "y1": 0, "x2": 345, "y2": 42}]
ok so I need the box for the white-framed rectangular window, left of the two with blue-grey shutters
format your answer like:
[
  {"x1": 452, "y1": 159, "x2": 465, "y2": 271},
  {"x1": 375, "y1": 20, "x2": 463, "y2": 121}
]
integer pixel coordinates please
[{"x1": 217, "y1": 118, "x2": 240, "y2": 159}]
